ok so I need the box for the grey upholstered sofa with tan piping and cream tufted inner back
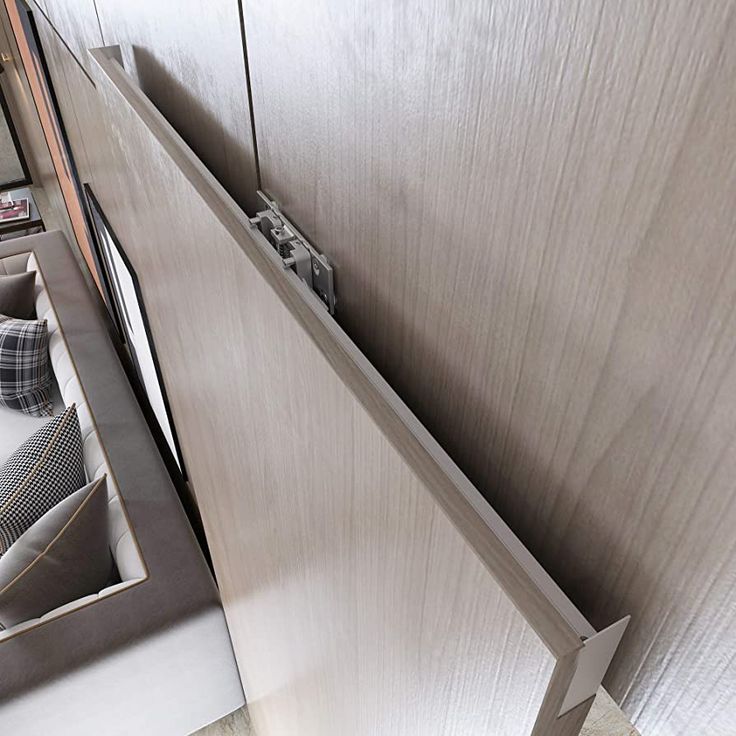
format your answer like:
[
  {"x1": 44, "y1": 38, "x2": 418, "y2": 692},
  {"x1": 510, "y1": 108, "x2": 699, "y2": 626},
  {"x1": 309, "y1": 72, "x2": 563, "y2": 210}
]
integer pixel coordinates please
[{"x1": 0, "y1": 232, "x2": 243, "y2": 736}]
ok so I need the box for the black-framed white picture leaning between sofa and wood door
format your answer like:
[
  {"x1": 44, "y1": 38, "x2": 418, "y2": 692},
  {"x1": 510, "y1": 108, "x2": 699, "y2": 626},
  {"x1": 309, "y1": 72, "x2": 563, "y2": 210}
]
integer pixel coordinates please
[{"x1": 84, "y1": 184, "x2": 186, "y2": 479}]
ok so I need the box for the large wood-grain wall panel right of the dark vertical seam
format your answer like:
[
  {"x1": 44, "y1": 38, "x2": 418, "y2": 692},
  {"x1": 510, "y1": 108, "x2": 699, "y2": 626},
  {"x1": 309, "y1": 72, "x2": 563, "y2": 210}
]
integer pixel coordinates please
[{"x1": 245, "y1": 0, "x2": 736, "y2": 736}]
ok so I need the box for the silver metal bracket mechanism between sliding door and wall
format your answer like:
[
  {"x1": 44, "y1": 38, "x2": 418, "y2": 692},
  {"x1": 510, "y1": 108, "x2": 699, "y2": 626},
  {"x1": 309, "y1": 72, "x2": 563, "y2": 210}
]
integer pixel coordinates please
[{"x1": 249, "y1": 192, "x2": 335, "y2": 314}]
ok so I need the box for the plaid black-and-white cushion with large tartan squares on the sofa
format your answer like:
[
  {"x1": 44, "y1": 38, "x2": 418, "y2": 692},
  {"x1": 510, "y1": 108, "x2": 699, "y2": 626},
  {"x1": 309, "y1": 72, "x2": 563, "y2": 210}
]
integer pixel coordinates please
[{"x1": 0, "y1": 314, "x2": 53, "y2": 417}]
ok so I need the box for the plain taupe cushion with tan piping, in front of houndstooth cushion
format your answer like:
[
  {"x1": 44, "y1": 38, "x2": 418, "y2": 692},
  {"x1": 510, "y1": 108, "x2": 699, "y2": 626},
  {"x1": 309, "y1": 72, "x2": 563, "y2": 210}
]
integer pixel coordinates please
[{"x1": 0, "y1": 476, "x2": 112, "y2": 628}]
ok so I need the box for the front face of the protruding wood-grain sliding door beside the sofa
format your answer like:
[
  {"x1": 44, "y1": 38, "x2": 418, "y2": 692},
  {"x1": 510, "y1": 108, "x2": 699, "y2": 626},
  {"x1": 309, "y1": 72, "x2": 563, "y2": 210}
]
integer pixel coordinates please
[{"x1": 82, "y1": 50, "x2": 604, "y2": 736}]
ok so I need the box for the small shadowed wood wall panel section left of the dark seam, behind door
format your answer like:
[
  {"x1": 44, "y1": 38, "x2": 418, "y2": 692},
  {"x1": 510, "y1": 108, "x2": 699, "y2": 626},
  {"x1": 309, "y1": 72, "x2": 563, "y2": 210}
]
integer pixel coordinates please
[{"x1": 91, "y1": 0, "x2": 258, "y2": 213}]
